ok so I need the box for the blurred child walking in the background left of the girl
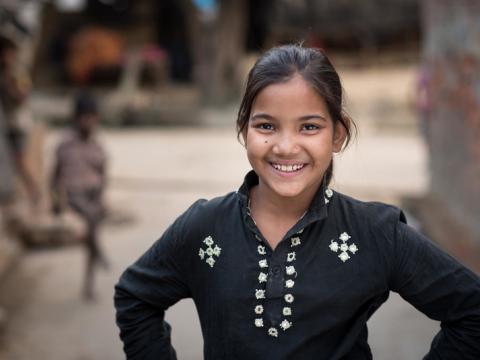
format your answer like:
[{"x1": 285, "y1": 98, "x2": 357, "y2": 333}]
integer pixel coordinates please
[{"x1": 51, "y1": 93, "x2": 108, "y2": 300}]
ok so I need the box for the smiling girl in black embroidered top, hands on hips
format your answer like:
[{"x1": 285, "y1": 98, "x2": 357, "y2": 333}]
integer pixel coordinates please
[{"x1": 115, "y1": 46, "x2": 480, "y2": 360}]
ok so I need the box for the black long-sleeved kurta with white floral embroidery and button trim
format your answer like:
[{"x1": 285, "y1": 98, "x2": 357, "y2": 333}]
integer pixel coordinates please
[{"x1": 115, "y1": 172, "x2": 480, "y2": 360}]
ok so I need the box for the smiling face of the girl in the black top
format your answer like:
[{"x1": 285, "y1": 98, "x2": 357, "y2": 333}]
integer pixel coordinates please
[{"x1": 243, "y1": 75, "x2": 346, "y2": 199}]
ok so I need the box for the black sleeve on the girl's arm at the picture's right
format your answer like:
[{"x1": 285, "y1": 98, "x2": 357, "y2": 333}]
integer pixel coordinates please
[{"x1": 391, "y1": 222, "x2": 480, "y2": 360}]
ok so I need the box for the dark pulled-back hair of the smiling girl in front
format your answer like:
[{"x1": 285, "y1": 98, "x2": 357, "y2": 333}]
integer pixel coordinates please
[{"x1": 237, "y1": 45, "x2": 356, "y2": 184}]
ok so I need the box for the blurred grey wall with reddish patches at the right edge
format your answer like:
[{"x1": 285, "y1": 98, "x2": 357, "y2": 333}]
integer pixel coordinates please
[{"x1": 420, "y1": 0, "x2": 480, "y2": 243}]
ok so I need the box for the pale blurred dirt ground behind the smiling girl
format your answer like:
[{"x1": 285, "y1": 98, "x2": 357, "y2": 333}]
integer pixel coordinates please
[{"x1": 0, "y1": 66, "x2": 439, "y2": 360}]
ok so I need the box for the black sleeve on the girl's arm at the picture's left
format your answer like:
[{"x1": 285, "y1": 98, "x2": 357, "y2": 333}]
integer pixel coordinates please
[{"x1": 114, "y1": 219, "x2": 190, "y2": 360}]
